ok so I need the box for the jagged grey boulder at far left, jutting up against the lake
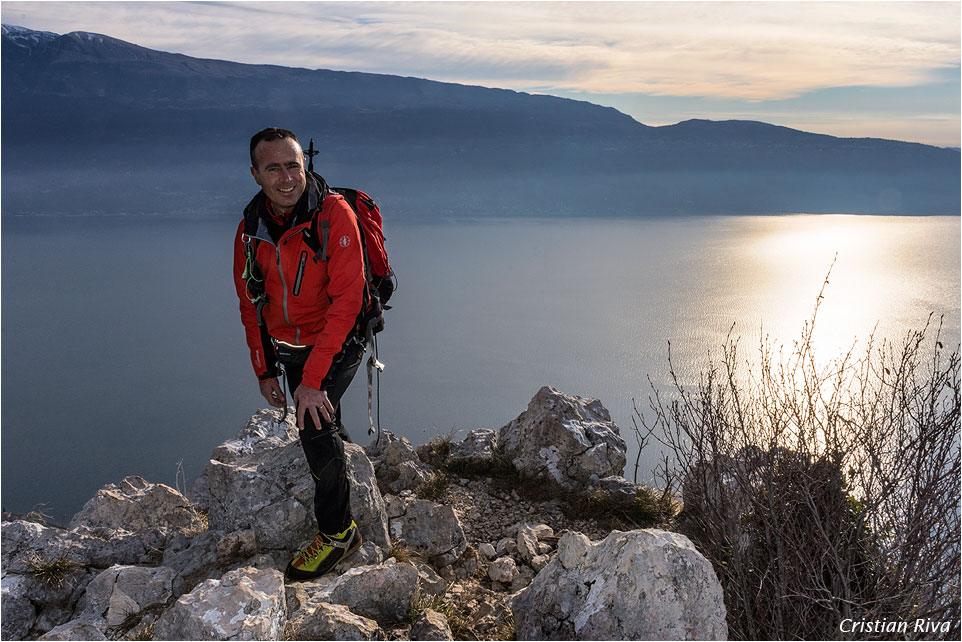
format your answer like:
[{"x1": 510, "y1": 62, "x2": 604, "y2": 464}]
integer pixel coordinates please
[{"x1": 68, "y1": 477, "x2": 206, "y2": 532}]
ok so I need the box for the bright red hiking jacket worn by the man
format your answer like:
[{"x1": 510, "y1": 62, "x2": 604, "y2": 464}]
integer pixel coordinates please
[{"x1": 234, "y1": 176, "x2": 365, "y2": 389}]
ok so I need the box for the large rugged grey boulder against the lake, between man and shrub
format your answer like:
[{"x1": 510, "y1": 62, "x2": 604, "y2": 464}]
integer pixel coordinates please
[{"x1": 498, "y1": 386, "x2": 628, "y2": 490}]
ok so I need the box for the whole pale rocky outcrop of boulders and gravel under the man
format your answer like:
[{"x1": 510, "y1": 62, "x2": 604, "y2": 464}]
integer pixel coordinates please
[{"x1": 2, "y1": 388, "x2": 725, "y2": 640}]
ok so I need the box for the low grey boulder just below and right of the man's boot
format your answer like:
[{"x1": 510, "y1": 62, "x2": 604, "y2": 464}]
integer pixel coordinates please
[{"x1": 318, "y1": 557, "x2": 443, "y2": 623}]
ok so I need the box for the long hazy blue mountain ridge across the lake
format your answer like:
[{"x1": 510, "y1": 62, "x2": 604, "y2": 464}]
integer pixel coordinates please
[{"x1": 2, "y1": 25, "x2": 960, "y2": 216}]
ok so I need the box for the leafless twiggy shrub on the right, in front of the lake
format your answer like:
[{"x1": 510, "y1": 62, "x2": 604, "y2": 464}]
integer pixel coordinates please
[{"x1": 636, "y1": 272, "x2": 962, "y2": 640}]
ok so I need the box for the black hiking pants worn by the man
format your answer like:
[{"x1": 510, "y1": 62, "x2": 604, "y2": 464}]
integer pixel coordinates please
[{"x1": 284, "y1": 343, "x2": 364, "y2": 535}]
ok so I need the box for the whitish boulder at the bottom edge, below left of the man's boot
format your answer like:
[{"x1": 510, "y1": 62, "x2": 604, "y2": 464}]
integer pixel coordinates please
[{"x1": 154, "y1": 567, "x2": 287, "y2": 640}]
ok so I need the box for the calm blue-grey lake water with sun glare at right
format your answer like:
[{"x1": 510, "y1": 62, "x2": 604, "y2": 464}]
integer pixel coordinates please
[{"x1": 2, "y1": 216, "x2": 960, "y2": 521}]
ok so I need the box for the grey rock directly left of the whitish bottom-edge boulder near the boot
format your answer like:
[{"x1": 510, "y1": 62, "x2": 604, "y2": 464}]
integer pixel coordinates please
[{"x1": 77, "y1": 565, "x2": 176, "y2": 626}]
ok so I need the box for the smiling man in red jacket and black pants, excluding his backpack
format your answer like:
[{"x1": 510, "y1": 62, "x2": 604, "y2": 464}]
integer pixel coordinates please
[{"x1": 234, "y1": 127, "x2": 365, "y2": 580}]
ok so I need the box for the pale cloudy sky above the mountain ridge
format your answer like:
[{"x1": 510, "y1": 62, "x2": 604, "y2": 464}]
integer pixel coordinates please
[{"x1": 0, "y1": 1, "x2": 962, "y2": 147}]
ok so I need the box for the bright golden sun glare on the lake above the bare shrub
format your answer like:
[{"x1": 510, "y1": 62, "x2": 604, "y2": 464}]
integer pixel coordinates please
[{"x1": 720, "y1": 215, "x2": 959, "y2": 361}]
